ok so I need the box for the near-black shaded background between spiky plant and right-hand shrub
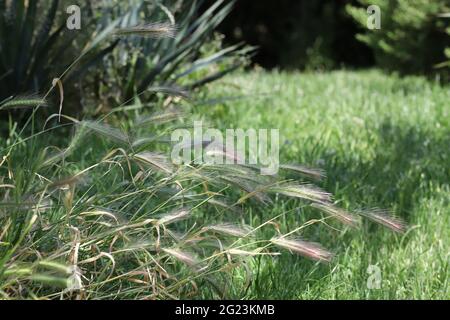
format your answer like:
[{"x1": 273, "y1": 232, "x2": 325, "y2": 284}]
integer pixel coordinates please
[{"x1": 216, "y1": 0, "x2": 373, "y2": 70}]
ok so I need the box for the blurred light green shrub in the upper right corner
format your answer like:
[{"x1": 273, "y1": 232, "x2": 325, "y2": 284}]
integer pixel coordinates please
[{"x1": 347, "y1": 0, "x2": 450, "y2": 77}]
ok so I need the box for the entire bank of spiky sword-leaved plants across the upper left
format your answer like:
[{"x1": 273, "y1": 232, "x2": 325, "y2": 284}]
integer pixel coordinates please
[{"x1": 0, "y1": 0, "x2": 248, "y2": 120}]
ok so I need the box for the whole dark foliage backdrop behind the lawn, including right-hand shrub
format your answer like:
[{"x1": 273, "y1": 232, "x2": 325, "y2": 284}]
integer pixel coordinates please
[{"x1": 216, "y1": 0, "x2": 450, "y2": 79}]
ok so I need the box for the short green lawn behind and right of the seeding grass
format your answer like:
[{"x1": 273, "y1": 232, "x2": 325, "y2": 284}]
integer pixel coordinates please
[{"x1": 204, "y1": 71, "x2": 450, "y2": 299}]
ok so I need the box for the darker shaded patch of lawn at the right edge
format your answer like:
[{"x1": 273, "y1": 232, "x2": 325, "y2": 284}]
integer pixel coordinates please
[{"x1": 322, "y1": 120, "x2": 450, "y2": 219}]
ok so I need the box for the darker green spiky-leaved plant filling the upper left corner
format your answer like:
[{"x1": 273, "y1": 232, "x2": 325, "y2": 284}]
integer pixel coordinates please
[{"x1": 0, "y1": 0, "x2": 119, "y2": 118}]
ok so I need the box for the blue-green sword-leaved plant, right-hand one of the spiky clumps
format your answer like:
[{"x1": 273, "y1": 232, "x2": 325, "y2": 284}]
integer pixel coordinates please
[{"x1": 87, "y1": 0, "x2": 251, "y2": 109}]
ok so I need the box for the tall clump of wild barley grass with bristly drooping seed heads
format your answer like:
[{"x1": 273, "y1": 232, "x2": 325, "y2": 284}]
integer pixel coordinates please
[{"x1": 0, "y1": 11, "x2": 408, "y2": 299}]
